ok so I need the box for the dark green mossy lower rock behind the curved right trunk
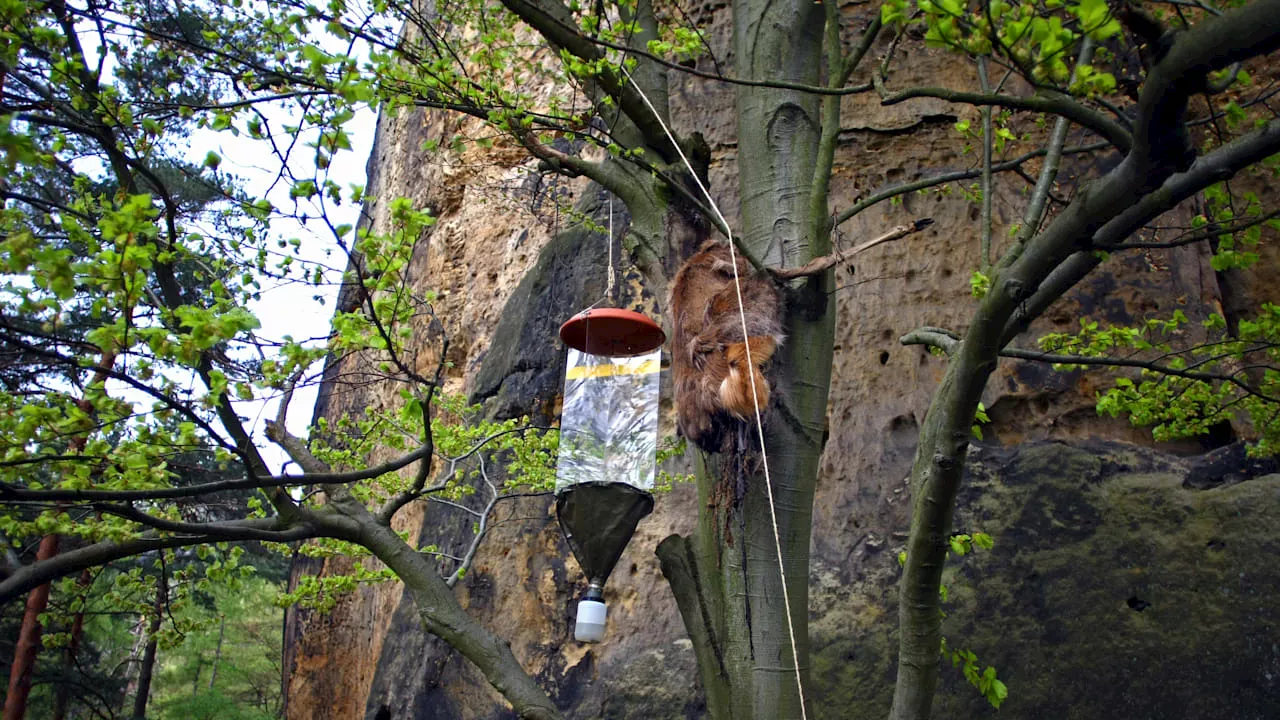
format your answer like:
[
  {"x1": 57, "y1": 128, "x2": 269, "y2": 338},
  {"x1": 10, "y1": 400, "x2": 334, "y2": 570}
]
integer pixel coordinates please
[{"x1": 813, "y1": 443, "x2": 1280, "y2": 720}]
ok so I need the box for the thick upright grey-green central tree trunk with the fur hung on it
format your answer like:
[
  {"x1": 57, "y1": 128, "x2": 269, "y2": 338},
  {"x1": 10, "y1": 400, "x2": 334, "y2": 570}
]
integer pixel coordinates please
[{"x1": 659, "y1": 0, "x2": 835, "y2": 720}]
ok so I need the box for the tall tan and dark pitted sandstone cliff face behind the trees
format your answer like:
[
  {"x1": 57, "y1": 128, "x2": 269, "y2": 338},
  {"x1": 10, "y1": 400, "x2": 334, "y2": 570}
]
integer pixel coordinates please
[{"x1": 285, "y1": 6, "x2": 1280, "y2": 719}]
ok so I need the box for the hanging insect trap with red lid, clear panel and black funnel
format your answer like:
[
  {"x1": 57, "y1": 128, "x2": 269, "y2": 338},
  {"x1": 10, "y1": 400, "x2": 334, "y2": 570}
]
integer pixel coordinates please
[{"x1": 556, "y1": 307, "x2": 666, "y2": 642}]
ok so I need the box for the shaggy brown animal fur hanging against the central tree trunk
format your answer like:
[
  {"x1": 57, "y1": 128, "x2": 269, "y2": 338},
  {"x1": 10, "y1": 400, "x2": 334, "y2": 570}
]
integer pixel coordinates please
[{"x1": 668, "y1": 241, "x2": 783, "y2": 452}]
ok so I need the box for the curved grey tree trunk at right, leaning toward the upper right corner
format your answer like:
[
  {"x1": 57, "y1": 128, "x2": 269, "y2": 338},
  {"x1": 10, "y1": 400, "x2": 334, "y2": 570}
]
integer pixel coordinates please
[{"x1": 891, "y1": 0, "x2": 1280, "y2": 720}]
